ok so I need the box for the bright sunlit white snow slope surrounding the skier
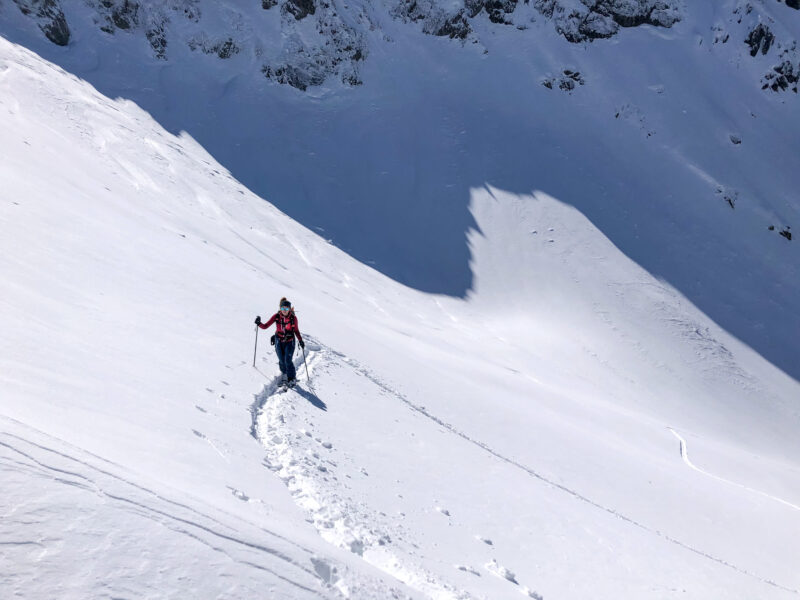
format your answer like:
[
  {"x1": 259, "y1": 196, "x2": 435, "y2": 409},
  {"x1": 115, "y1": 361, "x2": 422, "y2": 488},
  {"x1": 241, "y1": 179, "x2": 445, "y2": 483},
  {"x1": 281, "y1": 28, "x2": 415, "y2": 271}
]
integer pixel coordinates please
[{"x1": 0, "y1": 40, "x2": 800, "y2": 600}]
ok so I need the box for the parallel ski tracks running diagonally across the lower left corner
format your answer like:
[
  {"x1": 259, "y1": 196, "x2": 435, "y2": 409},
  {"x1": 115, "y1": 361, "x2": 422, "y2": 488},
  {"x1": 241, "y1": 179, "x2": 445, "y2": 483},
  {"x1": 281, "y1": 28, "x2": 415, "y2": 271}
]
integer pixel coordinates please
[{"x1": 0, "y1": 416, "x2": 332, "y2": 598}]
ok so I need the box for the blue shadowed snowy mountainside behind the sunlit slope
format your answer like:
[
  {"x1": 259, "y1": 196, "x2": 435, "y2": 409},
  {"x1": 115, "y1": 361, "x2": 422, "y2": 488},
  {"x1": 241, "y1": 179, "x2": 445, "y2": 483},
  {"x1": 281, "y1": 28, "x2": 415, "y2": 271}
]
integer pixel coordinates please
[{"x1": 0, "y1": 0, "x2": 800, "y2": 379}]
